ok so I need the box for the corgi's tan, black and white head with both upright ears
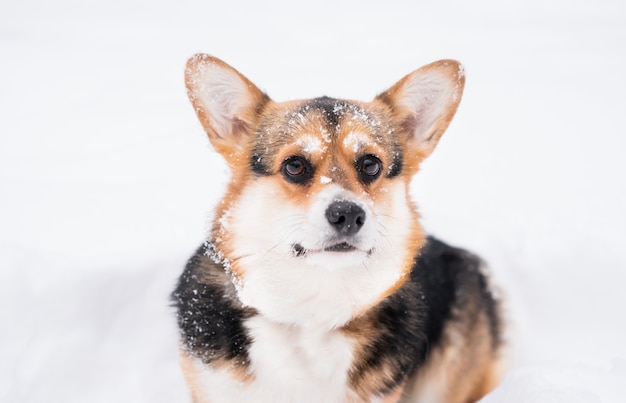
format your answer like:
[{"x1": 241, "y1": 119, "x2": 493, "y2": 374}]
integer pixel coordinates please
[{"x1": 186, "y1": 55, "x2": 464, "y2": 328}]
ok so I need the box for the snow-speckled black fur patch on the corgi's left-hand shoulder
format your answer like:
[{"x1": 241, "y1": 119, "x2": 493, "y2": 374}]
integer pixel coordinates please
[{"x1": 172, "y1": 246, "x2": 255, "y2": 368}]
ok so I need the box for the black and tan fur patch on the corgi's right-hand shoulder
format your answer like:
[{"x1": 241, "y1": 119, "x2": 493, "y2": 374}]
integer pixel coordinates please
[{"x1": 347, "y1": 237, "x2": 499, "y2": 394}]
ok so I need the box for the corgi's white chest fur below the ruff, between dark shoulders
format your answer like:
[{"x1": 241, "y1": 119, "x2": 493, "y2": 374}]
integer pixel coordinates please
[{"x1": 193, "y1": 317, "x2": 364, "y2": 402}]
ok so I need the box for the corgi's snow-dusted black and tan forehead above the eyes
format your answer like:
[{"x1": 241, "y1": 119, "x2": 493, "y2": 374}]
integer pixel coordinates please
[{"x1": 252, "y1": 97, "x2": 399, "y2": 173}]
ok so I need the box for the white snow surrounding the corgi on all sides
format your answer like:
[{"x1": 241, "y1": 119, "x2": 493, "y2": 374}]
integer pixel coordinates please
[{"x1": 0, "y1": 0, "x2": 626, "y2": 403}]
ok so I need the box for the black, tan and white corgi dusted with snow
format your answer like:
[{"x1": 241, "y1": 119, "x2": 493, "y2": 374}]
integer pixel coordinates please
[{"x1": 172, "y1": 54, "x2": 503, "y2": 403}]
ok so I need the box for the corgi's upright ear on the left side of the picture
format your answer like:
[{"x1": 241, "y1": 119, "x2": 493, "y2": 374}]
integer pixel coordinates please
[{"x1": 185, "y1": 54, "x2": 270, "y2": 161}]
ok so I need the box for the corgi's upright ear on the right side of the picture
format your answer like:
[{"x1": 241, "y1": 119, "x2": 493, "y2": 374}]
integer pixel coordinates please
[{"x1": 377, "y1": 60, "x2": 465, "y2": 160}]
